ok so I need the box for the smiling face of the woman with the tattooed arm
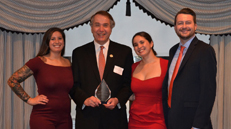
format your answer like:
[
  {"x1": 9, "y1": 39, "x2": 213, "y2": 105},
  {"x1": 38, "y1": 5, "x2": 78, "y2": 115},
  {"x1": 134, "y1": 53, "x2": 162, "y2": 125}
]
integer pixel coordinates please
[{"x1": 49, "y1": 31, "x2": 64, "y2": 53}]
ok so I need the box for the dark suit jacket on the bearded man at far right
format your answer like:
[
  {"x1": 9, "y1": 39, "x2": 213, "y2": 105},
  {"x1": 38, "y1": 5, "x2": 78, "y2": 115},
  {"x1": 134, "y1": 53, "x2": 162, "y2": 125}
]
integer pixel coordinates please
[{"x1": 163, "y1": 37, "x2": 217, "y2": 129}]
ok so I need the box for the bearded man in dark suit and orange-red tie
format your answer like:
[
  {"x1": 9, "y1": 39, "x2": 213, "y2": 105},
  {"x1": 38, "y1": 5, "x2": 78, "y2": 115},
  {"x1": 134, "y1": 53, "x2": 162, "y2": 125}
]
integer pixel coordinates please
[{"x1": 163, "y1": 8, "x2": 217, "y2": 129}]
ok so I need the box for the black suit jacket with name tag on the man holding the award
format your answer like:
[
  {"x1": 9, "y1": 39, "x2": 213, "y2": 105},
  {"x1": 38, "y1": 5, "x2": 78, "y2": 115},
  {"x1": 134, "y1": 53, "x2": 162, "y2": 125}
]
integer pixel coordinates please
[{"x1": 70, "y1": 41, "x2": 133, "y2": 129}]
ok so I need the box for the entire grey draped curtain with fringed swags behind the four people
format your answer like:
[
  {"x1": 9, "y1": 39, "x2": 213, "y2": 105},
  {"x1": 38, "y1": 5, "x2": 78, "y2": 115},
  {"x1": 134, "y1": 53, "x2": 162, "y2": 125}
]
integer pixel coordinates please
[{"x1": 0, "y1": 0, "x2": 231, "y2": 129}]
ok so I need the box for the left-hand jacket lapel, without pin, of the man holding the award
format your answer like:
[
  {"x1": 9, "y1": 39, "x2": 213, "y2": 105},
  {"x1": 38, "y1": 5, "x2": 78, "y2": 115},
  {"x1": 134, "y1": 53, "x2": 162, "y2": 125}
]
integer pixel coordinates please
[{"x1": 87, "y1": 42, "x2": 100, "y2": 82}]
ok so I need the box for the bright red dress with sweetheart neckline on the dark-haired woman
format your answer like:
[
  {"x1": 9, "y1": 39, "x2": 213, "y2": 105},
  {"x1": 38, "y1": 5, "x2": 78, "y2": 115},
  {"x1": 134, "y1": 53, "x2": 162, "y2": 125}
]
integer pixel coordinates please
[{"x1": 128, "y1": 58, "x2": 168, "y2": 129}]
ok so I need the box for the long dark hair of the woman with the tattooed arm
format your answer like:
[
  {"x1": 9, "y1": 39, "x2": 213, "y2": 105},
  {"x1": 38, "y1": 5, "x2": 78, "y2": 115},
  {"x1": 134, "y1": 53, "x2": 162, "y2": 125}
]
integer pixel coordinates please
[{"x1": 37, "y1": 27, "x2": 66, "y2": 56}]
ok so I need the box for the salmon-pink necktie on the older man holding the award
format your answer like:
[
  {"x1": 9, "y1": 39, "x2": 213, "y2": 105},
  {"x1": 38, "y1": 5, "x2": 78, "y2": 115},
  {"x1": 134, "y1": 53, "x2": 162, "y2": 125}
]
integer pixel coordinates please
[{"x1": 99, "y1": 46, "x2": 105, "y2": 80}]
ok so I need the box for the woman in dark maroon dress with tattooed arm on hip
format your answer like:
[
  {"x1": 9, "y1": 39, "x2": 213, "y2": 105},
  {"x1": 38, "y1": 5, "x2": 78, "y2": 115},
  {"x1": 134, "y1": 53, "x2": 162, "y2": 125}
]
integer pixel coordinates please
[{"x1": 8, "y1": 28, "x2": 73, "y2": 129}]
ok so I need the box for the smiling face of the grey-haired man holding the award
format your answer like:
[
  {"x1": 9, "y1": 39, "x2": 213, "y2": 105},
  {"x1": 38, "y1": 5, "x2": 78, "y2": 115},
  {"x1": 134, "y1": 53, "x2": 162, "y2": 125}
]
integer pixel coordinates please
[{"x1": 91, "y1": 14, "x2": 112, "y2": 45}]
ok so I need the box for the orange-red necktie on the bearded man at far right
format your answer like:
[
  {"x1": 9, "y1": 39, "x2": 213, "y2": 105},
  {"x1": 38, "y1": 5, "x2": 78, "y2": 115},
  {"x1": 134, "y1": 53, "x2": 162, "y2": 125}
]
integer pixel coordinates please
[{"x1": 168, "y1": 46, "x2": 185, "y2": 108}]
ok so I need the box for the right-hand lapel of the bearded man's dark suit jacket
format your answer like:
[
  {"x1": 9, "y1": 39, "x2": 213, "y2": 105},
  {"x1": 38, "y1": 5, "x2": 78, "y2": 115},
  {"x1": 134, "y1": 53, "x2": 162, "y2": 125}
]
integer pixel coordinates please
[{"x1": 178, "y1": 37, "x2": 198, "y2": 73}]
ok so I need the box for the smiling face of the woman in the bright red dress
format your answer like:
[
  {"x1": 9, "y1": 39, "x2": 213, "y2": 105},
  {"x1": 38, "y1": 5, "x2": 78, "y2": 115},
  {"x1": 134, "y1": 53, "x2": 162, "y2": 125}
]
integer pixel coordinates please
[{"x1": 133, "y1": 35, "x2": 153, "y2": 58}]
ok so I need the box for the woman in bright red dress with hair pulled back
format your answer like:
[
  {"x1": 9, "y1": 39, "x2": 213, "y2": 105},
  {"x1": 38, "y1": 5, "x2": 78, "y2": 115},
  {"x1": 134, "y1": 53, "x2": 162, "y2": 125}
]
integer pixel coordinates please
[{"x1": 128, "y1": 32, "x2": 168, "y2": 129}]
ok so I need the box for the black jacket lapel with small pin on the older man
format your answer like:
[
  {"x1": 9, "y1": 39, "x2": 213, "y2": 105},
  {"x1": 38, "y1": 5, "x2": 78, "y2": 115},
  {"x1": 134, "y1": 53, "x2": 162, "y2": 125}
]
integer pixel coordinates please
[{"x1": 103, "y1": 41, "x2": 117, "y2": 79}]
